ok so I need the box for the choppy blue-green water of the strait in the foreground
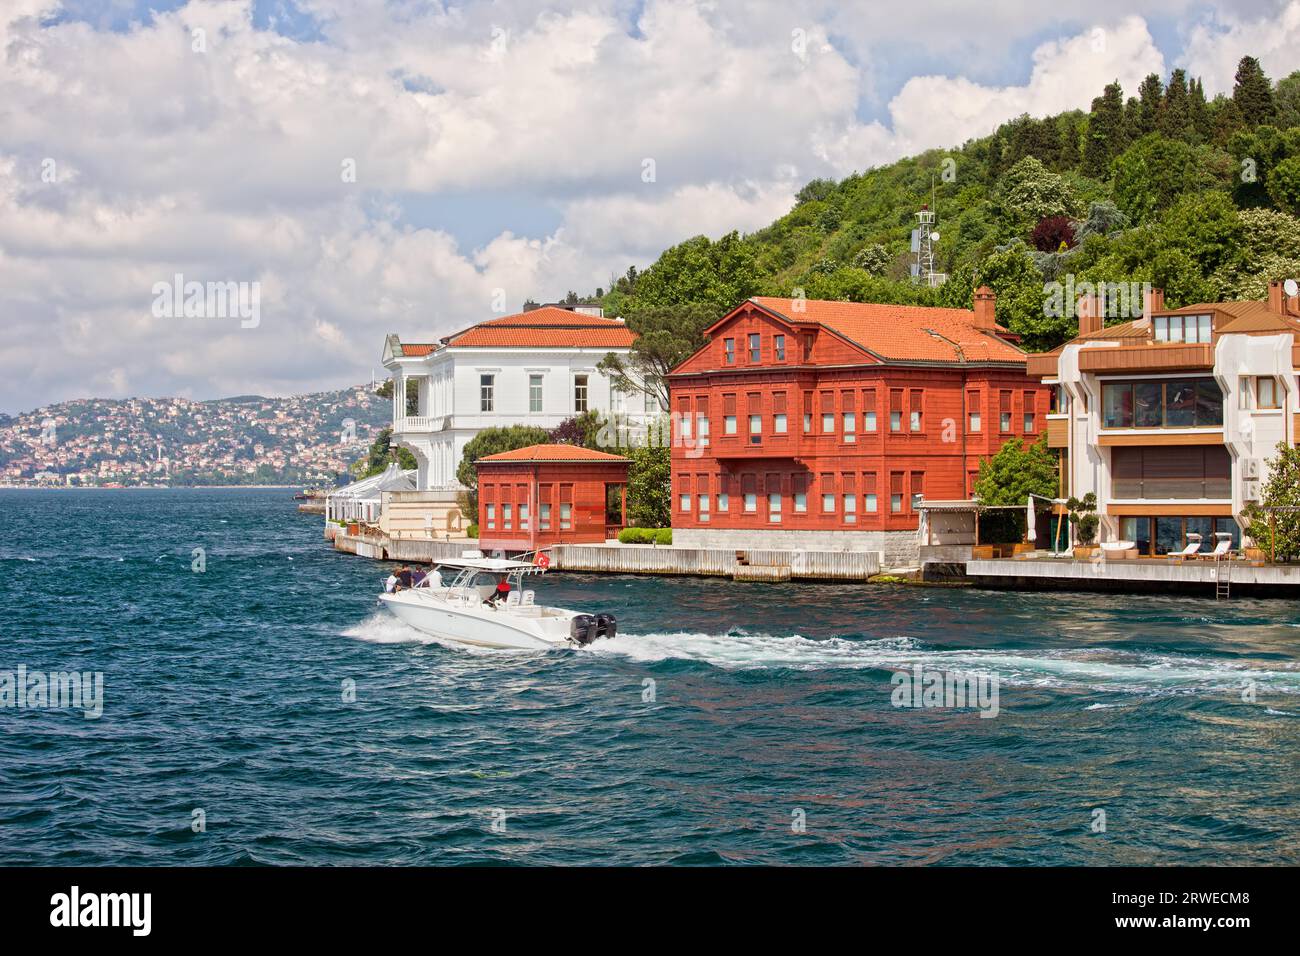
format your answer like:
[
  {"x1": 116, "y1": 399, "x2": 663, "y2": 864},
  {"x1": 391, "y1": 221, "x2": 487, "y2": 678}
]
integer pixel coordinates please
[{"x1": 0, "y1": 489, "x2": 1300, "y2": 865}]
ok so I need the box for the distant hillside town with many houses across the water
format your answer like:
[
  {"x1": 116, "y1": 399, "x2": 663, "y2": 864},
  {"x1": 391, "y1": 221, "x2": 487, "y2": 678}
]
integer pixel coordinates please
[{"x1": 0, "y1": 385, "x2": 390, "y2": 488}]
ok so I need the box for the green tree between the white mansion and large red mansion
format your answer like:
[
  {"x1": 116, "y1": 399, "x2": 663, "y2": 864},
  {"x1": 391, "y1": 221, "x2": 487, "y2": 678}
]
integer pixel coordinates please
[{"x1": 598, "y1": 300, "x2": 717, "y2": 410}]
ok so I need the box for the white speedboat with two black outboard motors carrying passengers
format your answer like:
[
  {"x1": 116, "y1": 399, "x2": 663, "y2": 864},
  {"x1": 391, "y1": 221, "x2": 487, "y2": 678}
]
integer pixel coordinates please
[{"x1": 380, "y1": 551, "x2": 618, "y2": 650}]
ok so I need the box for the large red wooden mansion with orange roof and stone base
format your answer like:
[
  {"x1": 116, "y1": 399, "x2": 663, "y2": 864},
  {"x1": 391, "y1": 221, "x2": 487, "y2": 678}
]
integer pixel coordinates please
[{"x1": 670, "y1": 287, "x2": 1048, "y2": 566}]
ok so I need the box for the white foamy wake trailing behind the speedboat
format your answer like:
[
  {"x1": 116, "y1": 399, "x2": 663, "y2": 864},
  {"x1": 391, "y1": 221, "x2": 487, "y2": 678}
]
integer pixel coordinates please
[{"x1": 582, "y1": 632, "x2": 1300, "y2": 696}]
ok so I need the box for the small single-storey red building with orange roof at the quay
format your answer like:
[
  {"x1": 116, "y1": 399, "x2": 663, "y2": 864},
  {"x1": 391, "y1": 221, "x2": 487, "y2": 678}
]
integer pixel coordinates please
[{"x1": 476, "y1": 445, "x2": 631, "y2": 551}]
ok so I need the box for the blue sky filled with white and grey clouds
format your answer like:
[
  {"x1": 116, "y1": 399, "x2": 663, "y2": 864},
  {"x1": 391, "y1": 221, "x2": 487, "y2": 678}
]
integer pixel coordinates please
[{"x1": 0, "y1": 0, "x2": 1300, "y2": 414}]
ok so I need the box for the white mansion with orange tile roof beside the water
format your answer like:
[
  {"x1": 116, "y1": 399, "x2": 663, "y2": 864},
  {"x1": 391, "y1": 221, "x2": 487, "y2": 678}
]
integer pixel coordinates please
[{"x1": 384, "y1": 306, "x2": 659, "y2": 492}]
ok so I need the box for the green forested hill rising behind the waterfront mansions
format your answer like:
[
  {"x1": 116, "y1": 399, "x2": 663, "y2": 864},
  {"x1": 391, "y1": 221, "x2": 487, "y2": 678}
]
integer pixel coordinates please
[{"x1": 593, "y1": 57, "x2": 1300, "y2": 352}]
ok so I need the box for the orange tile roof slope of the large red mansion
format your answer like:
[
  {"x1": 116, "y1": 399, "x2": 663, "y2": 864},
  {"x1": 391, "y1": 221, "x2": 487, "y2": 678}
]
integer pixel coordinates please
[{"x1": 750, "y1": 297, "x2": 1026, "y2": 364}]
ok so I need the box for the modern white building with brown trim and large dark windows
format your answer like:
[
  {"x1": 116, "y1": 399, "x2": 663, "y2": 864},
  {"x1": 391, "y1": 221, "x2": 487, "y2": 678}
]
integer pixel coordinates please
[{"x1": 1028, "y1": 282, "x2": 1300, "y2": 555}]
